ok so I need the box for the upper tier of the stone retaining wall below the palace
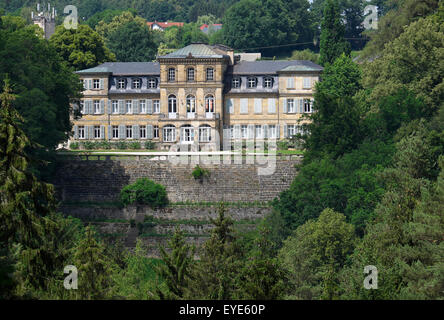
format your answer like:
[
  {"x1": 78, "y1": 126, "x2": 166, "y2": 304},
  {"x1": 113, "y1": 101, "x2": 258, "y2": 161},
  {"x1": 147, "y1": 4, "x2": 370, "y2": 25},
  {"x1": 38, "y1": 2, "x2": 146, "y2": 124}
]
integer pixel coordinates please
[{"x1": 54, "y1": 159, "x2": 300, "y2": 202}]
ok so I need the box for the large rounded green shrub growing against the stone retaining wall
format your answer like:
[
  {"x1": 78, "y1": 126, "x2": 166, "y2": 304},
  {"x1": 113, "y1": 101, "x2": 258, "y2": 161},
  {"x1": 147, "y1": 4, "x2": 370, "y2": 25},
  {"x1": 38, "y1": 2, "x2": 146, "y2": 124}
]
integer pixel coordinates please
[{"x1": 120, "y1": 178, "x2": 168, "y2": 208}]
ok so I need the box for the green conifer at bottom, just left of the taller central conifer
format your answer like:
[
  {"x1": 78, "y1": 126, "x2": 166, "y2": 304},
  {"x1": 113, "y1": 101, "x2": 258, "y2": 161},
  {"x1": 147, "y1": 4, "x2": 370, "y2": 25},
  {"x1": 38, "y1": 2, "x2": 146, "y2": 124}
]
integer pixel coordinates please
[{"x1": 156, "y1": 228, "x2": 195, "y2": 300}]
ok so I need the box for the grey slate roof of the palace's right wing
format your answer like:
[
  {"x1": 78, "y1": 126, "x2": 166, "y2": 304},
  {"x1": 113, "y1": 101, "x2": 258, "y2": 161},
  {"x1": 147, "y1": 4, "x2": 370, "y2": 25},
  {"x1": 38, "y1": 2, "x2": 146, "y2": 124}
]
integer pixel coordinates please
[{"x1": 233, "y1": 60, "x2": 323, "y2": 75}]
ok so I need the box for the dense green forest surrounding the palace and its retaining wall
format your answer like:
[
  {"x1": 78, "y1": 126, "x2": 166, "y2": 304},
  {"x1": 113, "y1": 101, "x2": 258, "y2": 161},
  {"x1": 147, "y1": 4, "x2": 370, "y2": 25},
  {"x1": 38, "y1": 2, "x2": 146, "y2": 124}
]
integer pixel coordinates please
[{"x1": 0, "y1": 0, "x2": 444, "y2": 300}]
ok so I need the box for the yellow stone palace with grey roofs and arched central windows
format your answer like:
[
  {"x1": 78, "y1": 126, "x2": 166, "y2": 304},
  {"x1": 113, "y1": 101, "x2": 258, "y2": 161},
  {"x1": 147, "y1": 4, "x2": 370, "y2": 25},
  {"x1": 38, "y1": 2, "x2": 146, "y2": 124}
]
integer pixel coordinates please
[{"x1": 71, "y1": 43, "x2": 322, "y2": 150}]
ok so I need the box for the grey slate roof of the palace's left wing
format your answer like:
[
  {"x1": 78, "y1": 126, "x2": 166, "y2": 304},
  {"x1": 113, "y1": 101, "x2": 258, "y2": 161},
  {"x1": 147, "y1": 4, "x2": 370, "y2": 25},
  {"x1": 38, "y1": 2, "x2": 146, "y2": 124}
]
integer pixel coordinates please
[{"x1": 77, "y1": 62, "x2": 160, "y2": 76}]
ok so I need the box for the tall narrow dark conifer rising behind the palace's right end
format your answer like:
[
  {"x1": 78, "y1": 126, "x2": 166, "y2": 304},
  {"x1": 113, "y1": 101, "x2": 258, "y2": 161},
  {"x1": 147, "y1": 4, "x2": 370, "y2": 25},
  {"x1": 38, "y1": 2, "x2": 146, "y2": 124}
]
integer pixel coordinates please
[{"x1": 319, "y1": 0, "x2": 350, "y2": 66}]
